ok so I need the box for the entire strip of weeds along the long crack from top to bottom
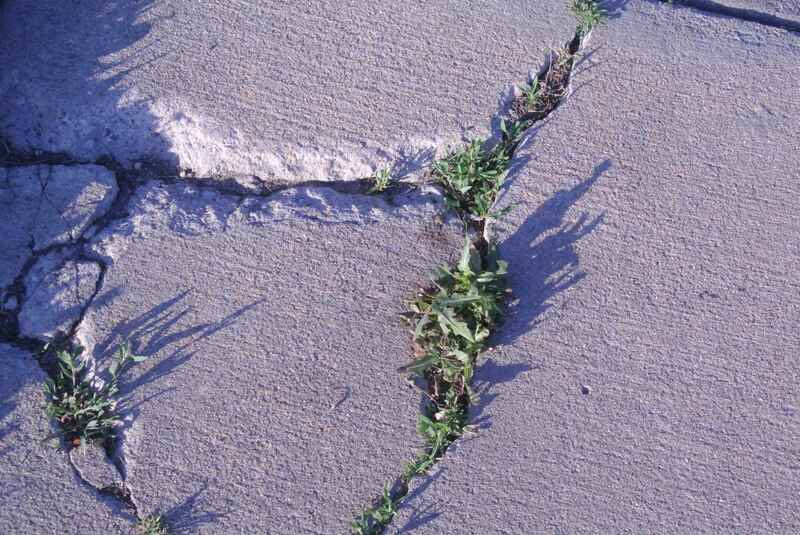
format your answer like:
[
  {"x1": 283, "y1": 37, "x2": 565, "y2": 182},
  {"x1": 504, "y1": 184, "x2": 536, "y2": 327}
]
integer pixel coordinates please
[{"x1": 351, "y1": 7, "x2": 588, "y2": 535}]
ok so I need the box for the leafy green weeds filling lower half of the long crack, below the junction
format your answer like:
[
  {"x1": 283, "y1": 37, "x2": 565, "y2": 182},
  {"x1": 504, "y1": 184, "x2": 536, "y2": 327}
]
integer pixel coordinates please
[{"x1": 351, "y1": 239, "x2": 507, "y2": 535}]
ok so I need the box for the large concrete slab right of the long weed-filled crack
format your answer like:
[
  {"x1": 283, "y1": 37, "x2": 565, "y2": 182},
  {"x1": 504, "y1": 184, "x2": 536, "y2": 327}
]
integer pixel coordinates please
[{"x1": 389, "y1": 3, "x2": 800, "y2": 534}]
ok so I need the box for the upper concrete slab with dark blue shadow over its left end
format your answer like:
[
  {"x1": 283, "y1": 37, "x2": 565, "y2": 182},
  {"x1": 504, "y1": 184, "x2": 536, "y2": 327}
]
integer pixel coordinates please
[{"x1": 0, "y1": 0, "x2": 575, "y2": 180}]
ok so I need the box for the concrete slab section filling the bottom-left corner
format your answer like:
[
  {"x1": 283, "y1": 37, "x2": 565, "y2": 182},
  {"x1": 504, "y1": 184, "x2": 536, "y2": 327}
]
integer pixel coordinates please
[{"x1": 0, "y1": 344, "x2": 131, "y2": 535}]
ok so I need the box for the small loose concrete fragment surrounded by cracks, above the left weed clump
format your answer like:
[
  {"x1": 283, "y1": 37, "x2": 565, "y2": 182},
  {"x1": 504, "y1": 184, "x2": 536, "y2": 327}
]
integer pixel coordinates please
[{"x1": 19, "y1": 251, "x2": 100, "y2": 341}]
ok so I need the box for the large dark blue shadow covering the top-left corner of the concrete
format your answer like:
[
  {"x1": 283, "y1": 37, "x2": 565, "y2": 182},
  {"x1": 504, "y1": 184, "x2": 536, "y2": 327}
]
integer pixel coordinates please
[{"x1": 0, "y1": 0, "x2": 179, "y2": 169}]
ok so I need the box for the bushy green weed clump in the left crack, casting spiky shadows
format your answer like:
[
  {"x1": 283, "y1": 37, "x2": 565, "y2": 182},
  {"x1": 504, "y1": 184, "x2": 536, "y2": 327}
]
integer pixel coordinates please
[{"x1": 44, "y1": 343, "x2": 146, "y2": 446}]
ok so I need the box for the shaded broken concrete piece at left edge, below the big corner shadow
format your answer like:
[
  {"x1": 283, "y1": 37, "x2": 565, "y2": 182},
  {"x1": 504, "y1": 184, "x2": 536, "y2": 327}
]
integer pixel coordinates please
[{"x1": 0, "y1": 165, "x2": 117, "y2": 288}]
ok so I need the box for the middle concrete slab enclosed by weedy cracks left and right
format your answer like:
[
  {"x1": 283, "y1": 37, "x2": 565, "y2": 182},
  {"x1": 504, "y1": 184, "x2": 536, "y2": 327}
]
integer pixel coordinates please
[{"x1": 80, "y1": 182, "x2": 463, "y2": 533}]
